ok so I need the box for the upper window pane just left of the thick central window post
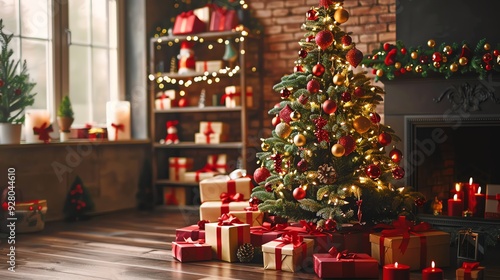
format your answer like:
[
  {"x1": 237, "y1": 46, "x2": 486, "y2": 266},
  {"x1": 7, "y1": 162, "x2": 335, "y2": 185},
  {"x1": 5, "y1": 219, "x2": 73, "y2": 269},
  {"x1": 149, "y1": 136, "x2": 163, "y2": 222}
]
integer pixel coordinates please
[{"x1": 20, "y1": 0, "x2": 48, "y2": 39}]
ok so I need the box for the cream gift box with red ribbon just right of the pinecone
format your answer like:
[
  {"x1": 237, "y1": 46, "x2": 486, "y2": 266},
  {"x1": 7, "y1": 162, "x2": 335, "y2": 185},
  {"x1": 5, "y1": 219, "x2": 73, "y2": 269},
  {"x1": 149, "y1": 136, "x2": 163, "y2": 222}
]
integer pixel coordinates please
[{"x1": 262, "y1": 233, "x2": 314, "y2": 272}]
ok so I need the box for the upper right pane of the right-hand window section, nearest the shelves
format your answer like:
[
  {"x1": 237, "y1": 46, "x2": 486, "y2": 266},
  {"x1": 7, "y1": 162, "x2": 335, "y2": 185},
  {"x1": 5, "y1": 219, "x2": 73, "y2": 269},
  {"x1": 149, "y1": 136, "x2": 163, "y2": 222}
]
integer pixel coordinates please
[{"x1": 92, "y1": 0, "x2": 108, "y2": 46}]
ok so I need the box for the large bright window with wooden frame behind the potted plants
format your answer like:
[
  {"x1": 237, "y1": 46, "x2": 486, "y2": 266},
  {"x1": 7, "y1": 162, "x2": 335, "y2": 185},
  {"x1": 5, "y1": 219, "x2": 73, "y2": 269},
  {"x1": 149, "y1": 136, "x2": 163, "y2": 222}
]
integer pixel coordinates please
[{"x1": 0, "y1": 0, "x2": 124, "y2": 125}]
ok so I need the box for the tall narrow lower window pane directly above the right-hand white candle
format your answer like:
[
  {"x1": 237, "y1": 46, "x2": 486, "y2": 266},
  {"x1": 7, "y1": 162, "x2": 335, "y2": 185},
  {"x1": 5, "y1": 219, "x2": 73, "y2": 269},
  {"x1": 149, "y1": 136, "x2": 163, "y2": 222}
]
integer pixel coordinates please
[{"x1": 92, "y1": 48, "x2": 110, "y2": 124}]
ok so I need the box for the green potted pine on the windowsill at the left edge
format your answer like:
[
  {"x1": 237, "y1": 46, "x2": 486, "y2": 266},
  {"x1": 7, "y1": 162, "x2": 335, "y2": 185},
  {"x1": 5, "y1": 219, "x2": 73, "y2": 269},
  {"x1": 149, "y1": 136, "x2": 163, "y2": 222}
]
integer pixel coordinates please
[{"x1": 0, "y1": 19, "x2": 36, "y2": 144}]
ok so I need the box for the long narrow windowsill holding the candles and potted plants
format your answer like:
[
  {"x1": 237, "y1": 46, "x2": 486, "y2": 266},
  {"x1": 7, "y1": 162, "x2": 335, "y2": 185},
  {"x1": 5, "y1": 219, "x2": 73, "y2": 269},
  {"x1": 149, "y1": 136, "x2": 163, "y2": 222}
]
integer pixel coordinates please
[{"x1": 0, "y1": 139, "x2": 151, "y2": 149}]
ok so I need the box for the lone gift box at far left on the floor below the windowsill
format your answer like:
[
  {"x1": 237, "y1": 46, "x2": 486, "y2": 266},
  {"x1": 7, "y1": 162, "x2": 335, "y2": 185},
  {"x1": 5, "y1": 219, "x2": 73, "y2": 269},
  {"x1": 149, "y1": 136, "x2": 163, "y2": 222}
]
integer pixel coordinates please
[{"x1": 15, "y1": 199, "x2": 47, "y2": 233}]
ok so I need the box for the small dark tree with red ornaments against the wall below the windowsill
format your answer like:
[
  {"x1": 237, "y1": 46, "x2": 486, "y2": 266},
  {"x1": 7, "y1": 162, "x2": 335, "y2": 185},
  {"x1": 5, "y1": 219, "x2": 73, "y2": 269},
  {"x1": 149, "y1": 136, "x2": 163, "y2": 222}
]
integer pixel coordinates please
[{"x1": 64, "y1": 176, "x2": 94, "y2": 221}]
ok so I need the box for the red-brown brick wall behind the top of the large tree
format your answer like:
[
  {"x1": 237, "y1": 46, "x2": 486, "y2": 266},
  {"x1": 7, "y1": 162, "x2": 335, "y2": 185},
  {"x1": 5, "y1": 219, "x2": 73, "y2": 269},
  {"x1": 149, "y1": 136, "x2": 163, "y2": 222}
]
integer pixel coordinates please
[{"x1": 247, "y1": 0, "x2": 396, "y2": 132}]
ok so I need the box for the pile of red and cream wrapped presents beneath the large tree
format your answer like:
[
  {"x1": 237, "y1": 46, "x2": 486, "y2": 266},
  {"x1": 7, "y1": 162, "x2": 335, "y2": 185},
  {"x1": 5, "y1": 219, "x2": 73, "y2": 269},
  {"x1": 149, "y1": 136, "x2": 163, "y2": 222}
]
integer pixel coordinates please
[{"x1": 172, "y1": 168, "x2": 488, "y2": 279}]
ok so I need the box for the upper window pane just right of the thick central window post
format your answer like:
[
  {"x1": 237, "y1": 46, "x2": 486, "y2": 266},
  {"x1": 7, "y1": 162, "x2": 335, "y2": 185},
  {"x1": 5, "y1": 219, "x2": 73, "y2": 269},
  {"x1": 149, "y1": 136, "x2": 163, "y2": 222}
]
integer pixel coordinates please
[{"x1": 68, "y1": 0, "x2": 91, "y2": 44}]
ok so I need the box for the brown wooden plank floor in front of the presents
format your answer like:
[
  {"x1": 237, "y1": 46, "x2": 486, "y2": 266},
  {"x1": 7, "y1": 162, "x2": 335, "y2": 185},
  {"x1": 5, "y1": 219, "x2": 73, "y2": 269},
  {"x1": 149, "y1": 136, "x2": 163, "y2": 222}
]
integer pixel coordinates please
[{"x1": 0, "y1": 209, "x2": 500, "y2": 280}]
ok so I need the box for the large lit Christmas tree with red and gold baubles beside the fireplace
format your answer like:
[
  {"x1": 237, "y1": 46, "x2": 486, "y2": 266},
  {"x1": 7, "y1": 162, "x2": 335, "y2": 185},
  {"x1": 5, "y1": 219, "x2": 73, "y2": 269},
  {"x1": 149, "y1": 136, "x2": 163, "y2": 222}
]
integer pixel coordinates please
[{"x1": 252, "y1": 0, "x2": 423, "y2": 229}]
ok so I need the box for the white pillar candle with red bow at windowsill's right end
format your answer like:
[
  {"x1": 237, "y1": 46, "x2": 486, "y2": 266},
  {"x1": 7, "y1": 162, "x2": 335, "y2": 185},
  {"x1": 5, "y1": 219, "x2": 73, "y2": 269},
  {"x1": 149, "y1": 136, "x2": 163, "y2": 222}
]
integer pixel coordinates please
[{"x1": 106, "y1": 101, "x2": 130, "y2": 141}]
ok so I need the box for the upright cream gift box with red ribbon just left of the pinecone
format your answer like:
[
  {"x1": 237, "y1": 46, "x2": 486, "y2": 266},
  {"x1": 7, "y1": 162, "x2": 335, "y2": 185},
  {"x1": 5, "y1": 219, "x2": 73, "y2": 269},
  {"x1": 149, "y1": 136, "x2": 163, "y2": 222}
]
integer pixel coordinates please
[{"x1": 205, "y1": 219, "x2": 250, "y2": 262}]
